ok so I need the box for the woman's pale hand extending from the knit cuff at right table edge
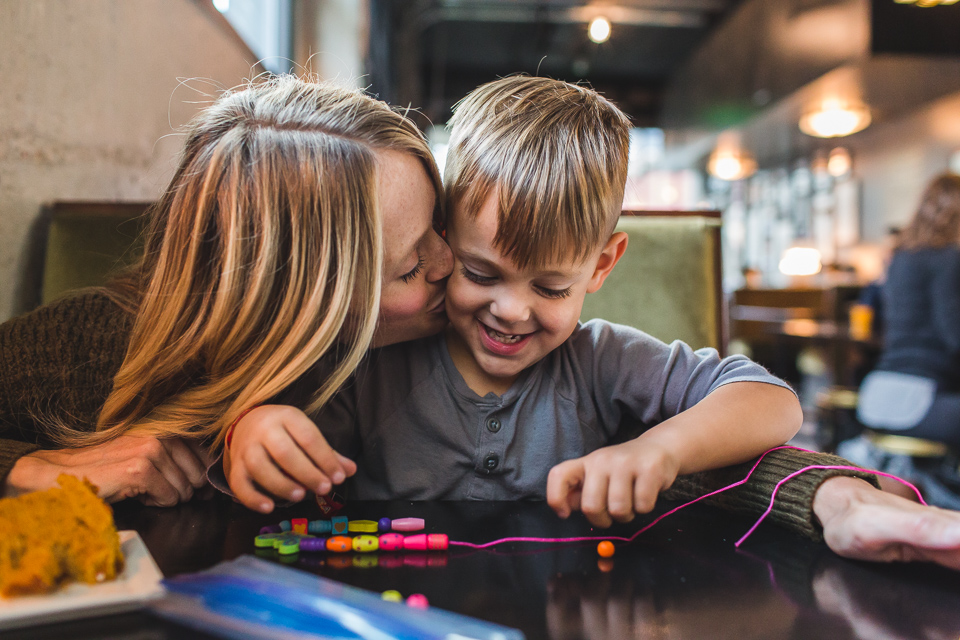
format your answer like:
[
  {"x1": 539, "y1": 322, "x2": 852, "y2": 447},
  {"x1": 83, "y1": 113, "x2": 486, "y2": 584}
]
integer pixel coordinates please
[{"x1": 813, "y1": 477, "x2": 960, "y2": 570}]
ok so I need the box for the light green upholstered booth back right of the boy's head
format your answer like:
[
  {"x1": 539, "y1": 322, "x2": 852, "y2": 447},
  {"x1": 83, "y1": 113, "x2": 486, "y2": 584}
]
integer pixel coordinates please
[{"x1": 580, "y1": 211, "x2": 725, "y2": 352}]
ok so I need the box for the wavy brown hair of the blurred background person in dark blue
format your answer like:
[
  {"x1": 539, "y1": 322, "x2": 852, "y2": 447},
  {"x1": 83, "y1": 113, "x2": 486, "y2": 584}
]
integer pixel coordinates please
[{"x1": 896, "y1": 173, "x2": 960, "y2": 250}]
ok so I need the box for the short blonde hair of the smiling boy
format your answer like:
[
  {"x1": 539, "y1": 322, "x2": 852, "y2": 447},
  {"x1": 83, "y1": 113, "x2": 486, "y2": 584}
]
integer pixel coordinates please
[{"x1": 444, "y1": 76, "x2": 630, "y2": 269}]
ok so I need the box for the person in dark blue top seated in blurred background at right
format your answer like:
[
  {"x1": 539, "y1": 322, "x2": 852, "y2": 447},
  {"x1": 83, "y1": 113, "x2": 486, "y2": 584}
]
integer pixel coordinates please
[{"x1": 842, "y1": 173, "x2": 960, "y2": 508}]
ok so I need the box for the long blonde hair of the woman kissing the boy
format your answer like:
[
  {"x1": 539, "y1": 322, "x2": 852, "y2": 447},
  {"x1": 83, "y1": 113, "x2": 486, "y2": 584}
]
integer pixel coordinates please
[{"x1": 57, "y1": 76, "x2": 440, "y2": 446}]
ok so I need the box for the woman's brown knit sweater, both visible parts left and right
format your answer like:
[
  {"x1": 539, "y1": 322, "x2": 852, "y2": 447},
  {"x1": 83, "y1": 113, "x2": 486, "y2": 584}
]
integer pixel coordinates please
[{"x1": 0, "y1": 293, "x2": 876, "y2": 538}]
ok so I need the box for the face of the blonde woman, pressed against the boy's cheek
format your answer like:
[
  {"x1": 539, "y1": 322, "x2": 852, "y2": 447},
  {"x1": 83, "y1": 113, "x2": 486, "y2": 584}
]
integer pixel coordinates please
[{"x1": 372, "y1": 150, "x2": 453, "y2": 347}]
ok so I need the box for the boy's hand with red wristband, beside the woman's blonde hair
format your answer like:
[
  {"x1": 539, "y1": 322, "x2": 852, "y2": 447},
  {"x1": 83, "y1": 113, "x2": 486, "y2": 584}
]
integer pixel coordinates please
[{"x1": 223, "y1": 405, "x2": 357, "y2": 513}]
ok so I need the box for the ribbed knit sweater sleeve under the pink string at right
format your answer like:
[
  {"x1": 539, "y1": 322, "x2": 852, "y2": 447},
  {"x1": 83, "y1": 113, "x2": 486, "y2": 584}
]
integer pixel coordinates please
[{"x1": 663, "y1": 449, "x2": 880, "y2": 541}]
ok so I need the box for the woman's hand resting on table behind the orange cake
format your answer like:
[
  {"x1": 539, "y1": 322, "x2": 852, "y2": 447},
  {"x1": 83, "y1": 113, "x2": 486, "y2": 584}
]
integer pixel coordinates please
[{"x1": 4, "y1": 435, "x2": 209, "y2": 507}]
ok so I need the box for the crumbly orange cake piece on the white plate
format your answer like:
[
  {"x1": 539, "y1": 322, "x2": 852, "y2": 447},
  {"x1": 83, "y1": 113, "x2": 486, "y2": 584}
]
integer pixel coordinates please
[{"x1": 0, "y1": 474, "x2": 123, "y2": 597}]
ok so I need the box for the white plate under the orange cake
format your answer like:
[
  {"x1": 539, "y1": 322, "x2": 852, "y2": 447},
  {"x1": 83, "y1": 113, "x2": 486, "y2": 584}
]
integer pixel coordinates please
[{"x1": 0, "y1": 531, "x2": 164, "y2": 629}]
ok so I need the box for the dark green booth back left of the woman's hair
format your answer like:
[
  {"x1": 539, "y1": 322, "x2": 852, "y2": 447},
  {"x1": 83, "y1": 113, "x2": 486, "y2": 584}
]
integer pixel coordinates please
[{"x1": 40, "y1": 202, "x2": 150, "y2": 304}]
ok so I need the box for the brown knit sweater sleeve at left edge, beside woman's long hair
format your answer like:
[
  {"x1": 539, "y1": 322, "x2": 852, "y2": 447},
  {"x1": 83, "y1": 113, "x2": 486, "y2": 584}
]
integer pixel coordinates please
[{"x1": 0, "y1": 293, "x2": 132, "y2": 486}]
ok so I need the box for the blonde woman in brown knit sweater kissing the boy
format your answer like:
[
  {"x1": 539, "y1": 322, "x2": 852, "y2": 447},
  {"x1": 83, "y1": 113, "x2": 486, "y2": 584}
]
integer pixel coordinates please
[{"x1": 0, "y1": 77, "x2": 960, "y2": 568}]
